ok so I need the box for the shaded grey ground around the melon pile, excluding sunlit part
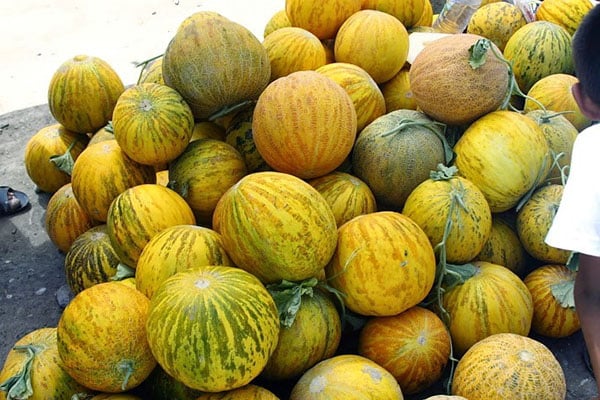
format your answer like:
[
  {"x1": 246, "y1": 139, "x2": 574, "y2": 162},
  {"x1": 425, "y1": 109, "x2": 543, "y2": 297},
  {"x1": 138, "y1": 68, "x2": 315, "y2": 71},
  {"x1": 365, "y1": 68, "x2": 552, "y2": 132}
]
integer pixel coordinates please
[{"x1": 0, "y1": 105, "x2": 596, "y2": 400}]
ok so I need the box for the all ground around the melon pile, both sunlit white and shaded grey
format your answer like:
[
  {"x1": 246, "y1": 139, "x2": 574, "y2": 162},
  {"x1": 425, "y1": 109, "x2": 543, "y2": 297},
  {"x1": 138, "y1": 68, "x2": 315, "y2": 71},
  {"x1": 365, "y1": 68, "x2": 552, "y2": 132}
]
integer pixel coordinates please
[{"x1": 0, "y1": 0, "x2": 597, "y2": 400}]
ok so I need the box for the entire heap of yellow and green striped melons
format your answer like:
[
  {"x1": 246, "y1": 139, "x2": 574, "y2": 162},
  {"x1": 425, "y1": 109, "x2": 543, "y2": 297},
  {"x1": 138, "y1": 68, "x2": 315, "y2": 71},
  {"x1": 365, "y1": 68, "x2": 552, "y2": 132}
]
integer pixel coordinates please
[{"x1": 0, "y1": 0, "x2": 592, "y2": 400}]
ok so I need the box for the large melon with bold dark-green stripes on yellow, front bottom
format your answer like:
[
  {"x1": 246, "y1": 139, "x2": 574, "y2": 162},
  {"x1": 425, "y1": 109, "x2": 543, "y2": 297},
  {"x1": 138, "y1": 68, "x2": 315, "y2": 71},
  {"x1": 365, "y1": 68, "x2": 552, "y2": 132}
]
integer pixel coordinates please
[{"x1": 146, "y1": 266, "x2": 280, "y2": 392}]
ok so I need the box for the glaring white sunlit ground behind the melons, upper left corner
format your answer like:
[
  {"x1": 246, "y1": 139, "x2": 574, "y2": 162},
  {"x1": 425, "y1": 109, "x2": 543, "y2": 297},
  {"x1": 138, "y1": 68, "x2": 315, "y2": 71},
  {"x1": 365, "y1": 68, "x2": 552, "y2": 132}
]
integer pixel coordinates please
[{"x1": 0, "y1": 0, "x2": 285, "y2": 115}]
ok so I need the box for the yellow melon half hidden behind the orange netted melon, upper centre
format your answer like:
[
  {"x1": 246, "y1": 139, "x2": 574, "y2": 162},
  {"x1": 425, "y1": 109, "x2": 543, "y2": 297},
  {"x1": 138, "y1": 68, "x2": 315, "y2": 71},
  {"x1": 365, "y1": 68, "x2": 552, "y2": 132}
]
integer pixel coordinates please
[{"x1": 316, "y1": 62, "x2": 386, "y2": 132}]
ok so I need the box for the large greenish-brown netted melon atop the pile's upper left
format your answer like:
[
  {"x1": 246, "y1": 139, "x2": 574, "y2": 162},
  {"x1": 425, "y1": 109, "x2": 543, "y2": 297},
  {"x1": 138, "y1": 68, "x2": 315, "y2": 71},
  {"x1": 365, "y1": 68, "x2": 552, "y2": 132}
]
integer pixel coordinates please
[{"x1": 162, "y1": 11, "x2": 271, "y2": 119}]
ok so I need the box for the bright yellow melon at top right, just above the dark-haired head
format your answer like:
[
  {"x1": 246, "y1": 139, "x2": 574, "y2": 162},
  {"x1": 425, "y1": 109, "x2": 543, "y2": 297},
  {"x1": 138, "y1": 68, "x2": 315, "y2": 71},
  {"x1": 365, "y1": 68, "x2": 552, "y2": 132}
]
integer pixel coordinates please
[{"x1": 535, "y1": 0, "x2": 594, "y2": 35}]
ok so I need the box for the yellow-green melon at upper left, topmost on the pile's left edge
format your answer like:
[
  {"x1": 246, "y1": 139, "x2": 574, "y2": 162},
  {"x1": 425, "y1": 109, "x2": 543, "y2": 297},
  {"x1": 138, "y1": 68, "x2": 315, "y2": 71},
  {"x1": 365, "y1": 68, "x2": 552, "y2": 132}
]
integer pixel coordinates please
[{"x1": 48, "y1": 55, "x2": 125, "y2": 133}]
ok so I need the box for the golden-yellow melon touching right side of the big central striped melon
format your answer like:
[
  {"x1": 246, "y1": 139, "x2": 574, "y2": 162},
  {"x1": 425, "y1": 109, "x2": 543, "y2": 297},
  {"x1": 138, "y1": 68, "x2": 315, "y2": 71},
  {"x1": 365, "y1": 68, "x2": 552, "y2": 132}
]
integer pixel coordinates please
[{"x1": 325, "y1": 211, "x2": 435, "y2": 316}]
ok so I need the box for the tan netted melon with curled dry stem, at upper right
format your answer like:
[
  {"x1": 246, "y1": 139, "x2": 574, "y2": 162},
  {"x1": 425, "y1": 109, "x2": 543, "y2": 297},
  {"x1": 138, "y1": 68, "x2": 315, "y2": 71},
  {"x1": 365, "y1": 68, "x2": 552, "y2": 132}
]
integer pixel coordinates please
[{"x1": 409, "y1": 33, "x2": 509, "y2": 125}]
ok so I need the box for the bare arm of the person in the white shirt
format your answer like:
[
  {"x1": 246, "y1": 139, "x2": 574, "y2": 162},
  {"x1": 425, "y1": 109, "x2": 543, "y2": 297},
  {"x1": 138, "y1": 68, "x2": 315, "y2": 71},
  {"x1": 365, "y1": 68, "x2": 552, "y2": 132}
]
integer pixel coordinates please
[{"x1": 575, "y1": 254, "x2": 600, "y2": 398}]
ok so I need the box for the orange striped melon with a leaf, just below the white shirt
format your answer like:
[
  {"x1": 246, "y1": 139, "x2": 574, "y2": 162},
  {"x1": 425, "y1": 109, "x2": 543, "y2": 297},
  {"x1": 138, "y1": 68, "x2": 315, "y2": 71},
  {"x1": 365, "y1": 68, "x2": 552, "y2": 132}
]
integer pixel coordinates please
[{"x1": 524, "y1": 264, "x2": 581, "y2": 338}]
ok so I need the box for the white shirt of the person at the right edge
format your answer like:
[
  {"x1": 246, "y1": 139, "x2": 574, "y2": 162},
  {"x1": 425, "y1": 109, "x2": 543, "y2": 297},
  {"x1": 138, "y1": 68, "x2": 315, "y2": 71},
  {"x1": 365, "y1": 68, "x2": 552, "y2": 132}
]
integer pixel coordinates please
[{"x1": 546, "y1": 124, "x2": 600, "y2": 257}]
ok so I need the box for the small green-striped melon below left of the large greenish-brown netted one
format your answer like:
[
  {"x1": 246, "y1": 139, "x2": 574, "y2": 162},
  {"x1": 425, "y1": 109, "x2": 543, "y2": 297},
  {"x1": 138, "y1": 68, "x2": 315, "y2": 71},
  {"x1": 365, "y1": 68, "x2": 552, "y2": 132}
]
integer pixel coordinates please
[{"x1": 112, "y1": 83, "x2": 194, "y2": 166}]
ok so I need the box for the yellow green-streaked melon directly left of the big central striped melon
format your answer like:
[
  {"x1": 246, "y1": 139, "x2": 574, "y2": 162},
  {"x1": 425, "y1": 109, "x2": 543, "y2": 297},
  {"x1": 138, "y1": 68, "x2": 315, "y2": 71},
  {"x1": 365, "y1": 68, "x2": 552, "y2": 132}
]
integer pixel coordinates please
[{"x1": 106, "y1": 184, "x2": 196, "y2": 268}]
